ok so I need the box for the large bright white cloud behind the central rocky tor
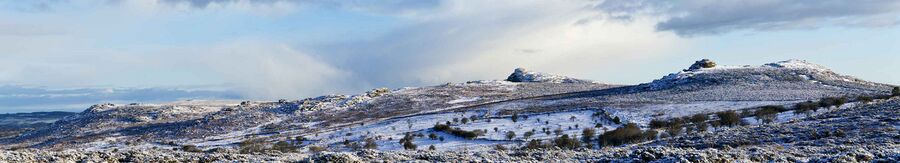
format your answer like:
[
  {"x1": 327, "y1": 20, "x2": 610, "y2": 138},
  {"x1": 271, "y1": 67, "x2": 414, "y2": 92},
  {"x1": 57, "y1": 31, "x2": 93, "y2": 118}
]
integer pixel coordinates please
[{"x1": 312, "y1": 1, "x2": 679, "y2": 87}]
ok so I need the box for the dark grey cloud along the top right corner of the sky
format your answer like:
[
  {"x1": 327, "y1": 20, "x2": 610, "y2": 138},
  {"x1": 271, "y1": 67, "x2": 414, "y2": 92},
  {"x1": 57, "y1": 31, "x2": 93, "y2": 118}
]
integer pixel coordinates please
[{"x1": 595, "y1": 0, "x2": 900, "y2": 36}]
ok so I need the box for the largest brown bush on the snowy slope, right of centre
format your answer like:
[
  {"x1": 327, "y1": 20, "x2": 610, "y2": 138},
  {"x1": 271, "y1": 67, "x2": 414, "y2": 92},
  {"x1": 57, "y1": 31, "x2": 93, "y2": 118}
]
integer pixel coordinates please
[{"x1": 598, "y1": 123, "x2": 656, "y2": 146}]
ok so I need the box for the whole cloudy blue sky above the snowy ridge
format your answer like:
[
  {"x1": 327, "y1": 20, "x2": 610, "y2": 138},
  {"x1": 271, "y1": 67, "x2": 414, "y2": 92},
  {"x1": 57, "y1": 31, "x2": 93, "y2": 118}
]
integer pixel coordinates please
[{"x1": 0, "y1": 0, "x2": 900, "y2": 112}]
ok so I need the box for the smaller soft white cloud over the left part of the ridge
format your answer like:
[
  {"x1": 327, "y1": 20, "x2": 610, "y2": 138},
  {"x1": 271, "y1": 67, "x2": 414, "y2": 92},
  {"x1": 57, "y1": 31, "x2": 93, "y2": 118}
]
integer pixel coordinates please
[{"x1": 153, "y1": 40, "x2": 353, "y2": 99}]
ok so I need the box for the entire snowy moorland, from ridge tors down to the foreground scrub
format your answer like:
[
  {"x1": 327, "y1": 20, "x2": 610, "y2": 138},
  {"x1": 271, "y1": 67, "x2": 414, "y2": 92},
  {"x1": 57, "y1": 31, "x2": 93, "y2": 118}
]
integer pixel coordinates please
[{"x1": 0, "y1": 60, "x2": 900, "y2": 162}]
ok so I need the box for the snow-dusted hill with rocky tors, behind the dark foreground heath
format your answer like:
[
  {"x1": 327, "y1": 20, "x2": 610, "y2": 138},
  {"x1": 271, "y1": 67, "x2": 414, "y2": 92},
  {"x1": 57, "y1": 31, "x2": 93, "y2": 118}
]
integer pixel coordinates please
[{"x1": 0, "y1": 60, "x2": 892, "y2": 162}]
